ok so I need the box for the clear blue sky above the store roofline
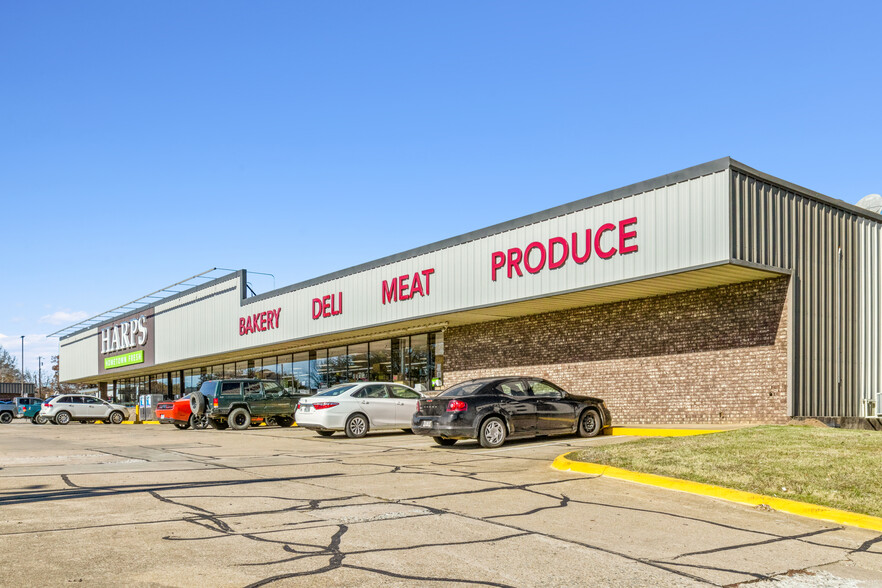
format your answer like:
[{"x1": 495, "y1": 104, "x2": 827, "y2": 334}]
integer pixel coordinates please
[{"x1": 0, "y1": 0, "x2": 882, "y2": 369}]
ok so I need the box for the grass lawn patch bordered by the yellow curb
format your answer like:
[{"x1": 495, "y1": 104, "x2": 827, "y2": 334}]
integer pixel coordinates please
[{"x1": 567, "y1": 426, "x2": 882, "y2": 516}]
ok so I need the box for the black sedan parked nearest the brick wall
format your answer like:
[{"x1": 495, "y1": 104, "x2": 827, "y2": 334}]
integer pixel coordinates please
[{"x1": 411, "y1": 376, "x2": 611, "y2": 447}]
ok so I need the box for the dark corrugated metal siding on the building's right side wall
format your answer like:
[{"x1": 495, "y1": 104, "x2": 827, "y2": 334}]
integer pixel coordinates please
[{"x1": 731, "y1": 168, "x2": 878, "y2": 416}]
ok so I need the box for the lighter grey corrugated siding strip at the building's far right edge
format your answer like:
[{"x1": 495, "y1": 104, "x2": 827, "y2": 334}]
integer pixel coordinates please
[{"x1": 858, "y1": 219, "x2": 882, "y2": 415}]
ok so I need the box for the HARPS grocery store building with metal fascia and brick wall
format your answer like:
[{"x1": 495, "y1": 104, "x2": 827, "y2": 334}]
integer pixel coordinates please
[{"x1": 60, "y1": 158, "x2": 882, "y2": 423}]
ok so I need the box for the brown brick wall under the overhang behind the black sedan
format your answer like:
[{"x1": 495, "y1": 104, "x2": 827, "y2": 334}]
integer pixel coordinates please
[{"x1": 444, "y1": 277, "x2": 788, "y2": 424}]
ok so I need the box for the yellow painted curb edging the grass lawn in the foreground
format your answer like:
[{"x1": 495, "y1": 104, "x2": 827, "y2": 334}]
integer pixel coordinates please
[{"x1": 551, "y1": 455, "x2": 882, "y2": 531}]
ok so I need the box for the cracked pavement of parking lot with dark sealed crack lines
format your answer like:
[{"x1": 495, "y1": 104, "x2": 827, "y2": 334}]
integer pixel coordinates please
[{"x1": 0, "y1": 421, "x2": 882, "y2": 587}]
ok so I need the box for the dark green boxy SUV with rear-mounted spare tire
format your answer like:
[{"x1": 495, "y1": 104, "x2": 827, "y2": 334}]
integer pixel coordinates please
[{"x1": 190, "y1": 378, "x2": 309, "y2": 431}]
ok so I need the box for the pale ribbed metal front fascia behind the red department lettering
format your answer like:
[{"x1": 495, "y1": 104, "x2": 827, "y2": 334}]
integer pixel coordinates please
[{"x1": 64, "y1": 170, "x2": 729, "y2": 378}]
